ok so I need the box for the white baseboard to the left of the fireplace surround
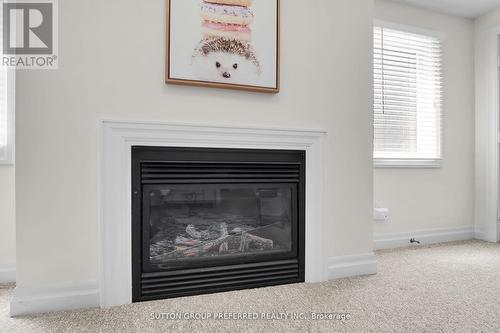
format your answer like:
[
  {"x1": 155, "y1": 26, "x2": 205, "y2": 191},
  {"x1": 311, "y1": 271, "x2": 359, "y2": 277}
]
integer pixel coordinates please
[{"x1": 10, "y1": 281, "x2": 99, "y2": 317}]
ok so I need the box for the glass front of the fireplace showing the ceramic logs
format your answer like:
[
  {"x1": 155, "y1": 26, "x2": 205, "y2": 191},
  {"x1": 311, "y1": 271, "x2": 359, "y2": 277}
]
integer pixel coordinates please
[{"x1": 143, "y1": 183, "x2": 297, "y2": 271}]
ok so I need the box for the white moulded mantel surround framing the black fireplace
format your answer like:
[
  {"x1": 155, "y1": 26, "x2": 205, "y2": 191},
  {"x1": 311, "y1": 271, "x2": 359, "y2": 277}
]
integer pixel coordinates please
[{"x1": 99, "y1": 120, "x2": 328, "y2": 306}]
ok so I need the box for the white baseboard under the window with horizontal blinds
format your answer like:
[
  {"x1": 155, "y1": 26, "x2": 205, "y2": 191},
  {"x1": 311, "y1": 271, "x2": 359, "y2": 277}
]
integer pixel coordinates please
[{"x1": 373, "y1": 226, "x2": 477, "y2": 250}]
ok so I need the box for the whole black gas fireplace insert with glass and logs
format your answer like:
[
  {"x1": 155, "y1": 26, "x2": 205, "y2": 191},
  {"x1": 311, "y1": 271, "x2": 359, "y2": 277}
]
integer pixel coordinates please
[{"x1": 132, "y1": 146, "x2": 305, "y2": 302}]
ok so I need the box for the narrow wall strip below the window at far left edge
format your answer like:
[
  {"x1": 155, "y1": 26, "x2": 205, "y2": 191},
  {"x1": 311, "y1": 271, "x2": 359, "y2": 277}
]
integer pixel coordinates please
[{"x1": 0, "y1": 165, "x2": 16, "y2": 270}]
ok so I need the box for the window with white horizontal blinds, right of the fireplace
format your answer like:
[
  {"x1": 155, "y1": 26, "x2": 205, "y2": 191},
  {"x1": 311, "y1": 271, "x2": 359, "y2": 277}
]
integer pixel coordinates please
[{"x1": 373, "y1": 26, "x2": 442, "y2": 167}]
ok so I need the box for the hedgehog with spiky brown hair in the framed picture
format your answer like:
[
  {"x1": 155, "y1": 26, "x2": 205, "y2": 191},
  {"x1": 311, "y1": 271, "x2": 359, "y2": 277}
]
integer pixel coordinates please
[{"x1": 192, "y1": 37, "x2": 261, "y2": 84}]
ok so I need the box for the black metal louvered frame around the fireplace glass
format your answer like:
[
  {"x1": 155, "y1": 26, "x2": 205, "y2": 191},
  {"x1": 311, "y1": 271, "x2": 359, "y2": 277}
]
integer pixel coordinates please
[{"x1": 131, "y1": 146, "x2": 306, "y2": 302}]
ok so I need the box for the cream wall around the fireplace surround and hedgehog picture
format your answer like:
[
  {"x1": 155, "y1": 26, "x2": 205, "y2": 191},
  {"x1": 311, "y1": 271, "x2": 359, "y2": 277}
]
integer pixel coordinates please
[{"x1": 16, "y1": 0, "x2": 373, "y2": 287}]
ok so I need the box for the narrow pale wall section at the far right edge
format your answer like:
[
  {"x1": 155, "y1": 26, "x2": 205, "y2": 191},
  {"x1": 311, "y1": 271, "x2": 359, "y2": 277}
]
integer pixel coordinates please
[{"x1": 475, "y1": 8, "x2": 500, "y2": 241}]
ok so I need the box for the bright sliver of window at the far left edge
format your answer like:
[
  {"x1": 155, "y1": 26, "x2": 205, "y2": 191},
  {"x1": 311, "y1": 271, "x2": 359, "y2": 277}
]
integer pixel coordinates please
[{"x1": 0, "y1": 11, "x2": 15, "y2": 164}]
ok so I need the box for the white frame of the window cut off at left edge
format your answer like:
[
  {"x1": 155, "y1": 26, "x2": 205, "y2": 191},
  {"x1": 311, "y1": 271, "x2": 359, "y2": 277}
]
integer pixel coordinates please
[{"x1": 0, "y1": 68, "x2": 16, "y2": 165}]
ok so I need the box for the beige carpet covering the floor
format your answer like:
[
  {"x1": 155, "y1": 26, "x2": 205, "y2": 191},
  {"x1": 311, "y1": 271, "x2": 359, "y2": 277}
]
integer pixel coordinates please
[{"x1": 0, "y1": 241, "x2": 500, "y2": 333}]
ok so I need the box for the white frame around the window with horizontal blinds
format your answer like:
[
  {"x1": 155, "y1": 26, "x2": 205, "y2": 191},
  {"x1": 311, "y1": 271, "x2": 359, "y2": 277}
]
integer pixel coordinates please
[{"x1": 373, "y1": 20, "x2": 446, "y2": 169}]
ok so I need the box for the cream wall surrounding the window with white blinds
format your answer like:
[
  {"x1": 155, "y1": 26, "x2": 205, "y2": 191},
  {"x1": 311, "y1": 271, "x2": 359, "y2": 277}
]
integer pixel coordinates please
[{"x1": 374, "y1": 0, "x2": 474, "y2": 238}]
